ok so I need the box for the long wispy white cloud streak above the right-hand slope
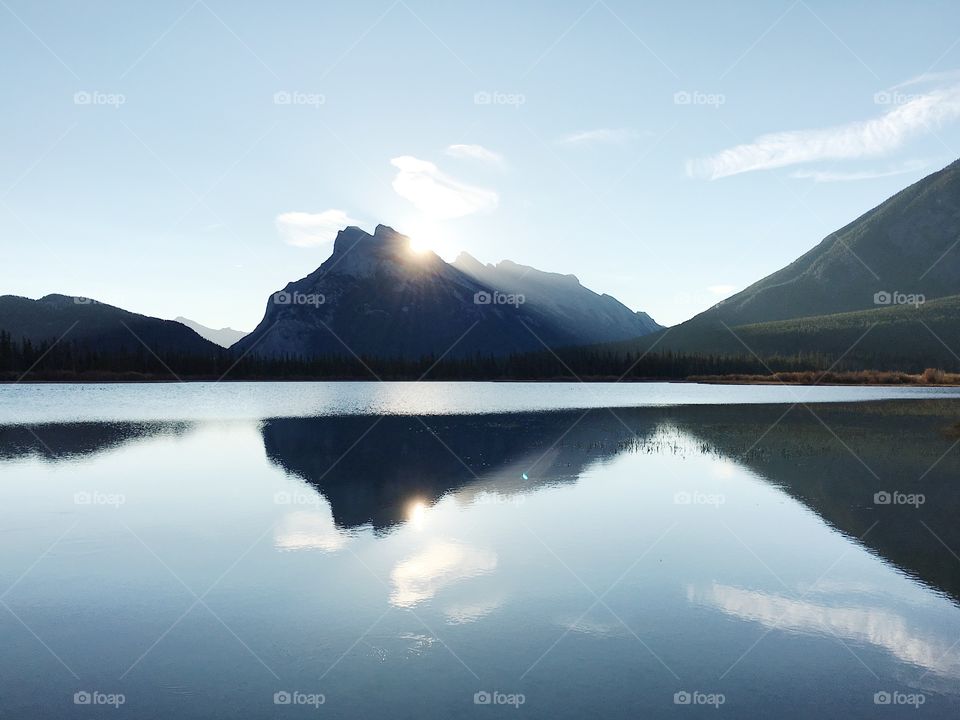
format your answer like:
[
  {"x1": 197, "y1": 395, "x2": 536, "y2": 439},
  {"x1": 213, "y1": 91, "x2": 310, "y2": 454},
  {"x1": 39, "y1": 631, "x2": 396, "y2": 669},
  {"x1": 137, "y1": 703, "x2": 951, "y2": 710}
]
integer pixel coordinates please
[{"x1": 687, "y1": 85, "x2": 960, "y2": 180}]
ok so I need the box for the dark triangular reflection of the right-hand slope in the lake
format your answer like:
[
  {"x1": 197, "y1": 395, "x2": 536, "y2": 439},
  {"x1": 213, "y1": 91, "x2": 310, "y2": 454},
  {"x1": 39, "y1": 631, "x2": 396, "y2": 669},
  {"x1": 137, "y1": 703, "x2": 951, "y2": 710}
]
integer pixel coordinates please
[{"x1": 671, "y1": 400, "x2": 960, "y2": 602}]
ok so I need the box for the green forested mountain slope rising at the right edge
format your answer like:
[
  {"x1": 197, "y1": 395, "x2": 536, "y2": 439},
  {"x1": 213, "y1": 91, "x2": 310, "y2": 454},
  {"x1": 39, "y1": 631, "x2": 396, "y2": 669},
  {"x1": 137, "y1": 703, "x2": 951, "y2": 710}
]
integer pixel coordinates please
[{"x1": 643, "y1": 155, "x2": 960, "y2": 364}]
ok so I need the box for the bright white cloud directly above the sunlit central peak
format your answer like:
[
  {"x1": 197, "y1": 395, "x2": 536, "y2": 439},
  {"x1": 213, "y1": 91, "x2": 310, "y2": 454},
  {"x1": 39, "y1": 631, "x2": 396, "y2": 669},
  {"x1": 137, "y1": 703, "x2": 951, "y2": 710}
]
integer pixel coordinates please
[{"x1": 390, "y1": 155, "x2": 500, "y2": 220}]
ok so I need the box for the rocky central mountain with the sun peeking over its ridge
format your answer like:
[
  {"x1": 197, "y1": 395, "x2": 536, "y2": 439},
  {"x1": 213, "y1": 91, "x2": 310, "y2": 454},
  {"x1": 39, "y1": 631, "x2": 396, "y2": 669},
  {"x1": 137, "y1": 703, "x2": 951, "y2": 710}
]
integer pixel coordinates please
[{"x1": 232, "y1": 225, "x2": 655, "y2": 359}]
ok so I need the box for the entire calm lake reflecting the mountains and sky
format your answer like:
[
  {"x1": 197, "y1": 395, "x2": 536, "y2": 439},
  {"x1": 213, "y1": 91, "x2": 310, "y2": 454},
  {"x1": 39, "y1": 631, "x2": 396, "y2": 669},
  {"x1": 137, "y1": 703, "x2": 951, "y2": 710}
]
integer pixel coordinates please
[{"x1": 0, "y1": 383, "x2": 960, "y2": 718}]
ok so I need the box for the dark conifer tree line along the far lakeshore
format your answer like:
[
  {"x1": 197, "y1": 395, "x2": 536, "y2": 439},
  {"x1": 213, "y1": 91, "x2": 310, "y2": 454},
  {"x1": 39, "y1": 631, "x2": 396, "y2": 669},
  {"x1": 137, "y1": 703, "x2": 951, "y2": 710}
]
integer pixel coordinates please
[{"x1": 0, "y1": 330, "x2": 832, "y2": 381}]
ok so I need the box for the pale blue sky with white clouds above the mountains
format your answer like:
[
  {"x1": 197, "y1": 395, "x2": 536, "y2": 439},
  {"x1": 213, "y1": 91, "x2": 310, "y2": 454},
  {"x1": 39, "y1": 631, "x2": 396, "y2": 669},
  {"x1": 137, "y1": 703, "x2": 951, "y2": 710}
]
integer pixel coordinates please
[{"x1": 0, "y1": 0, "x2": 960, "y2": 330}]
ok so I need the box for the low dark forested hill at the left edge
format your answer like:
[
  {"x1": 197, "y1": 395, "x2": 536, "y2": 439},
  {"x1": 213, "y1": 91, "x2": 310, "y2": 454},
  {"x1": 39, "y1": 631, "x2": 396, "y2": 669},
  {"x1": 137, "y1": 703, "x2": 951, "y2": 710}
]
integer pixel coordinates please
[{"x1": 0, "y1": 295, "x2": 220, "y2": 356}]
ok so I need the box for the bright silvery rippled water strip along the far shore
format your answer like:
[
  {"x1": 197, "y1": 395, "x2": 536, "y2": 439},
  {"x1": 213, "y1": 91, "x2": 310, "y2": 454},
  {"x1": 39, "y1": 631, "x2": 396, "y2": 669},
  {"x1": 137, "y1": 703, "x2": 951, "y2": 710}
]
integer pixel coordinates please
[{"x1": 0, "y1": 382, "x2": 960, "y2": 424}]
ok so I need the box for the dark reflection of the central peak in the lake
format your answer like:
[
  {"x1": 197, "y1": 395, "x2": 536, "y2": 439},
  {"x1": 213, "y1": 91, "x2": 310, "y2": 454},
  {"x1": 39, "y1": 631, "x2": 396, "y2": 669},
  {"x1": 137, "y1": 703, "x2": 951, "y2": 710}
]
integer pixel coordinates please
[{"x1": 262, "y1": 410, "x2": 656, "y2": 531}]
